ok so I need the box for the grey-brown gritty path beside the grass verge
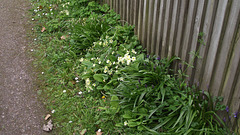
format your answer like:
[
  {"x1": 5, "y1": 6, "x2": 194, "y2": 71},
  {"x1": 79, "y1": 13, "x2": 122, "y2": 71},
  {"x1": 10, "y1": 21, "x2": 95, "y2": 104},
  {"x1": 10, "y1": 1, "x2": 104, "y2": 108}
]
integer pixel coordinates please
[{"x1": 0, "y1": 0, "x2": 46, "y2": 135}]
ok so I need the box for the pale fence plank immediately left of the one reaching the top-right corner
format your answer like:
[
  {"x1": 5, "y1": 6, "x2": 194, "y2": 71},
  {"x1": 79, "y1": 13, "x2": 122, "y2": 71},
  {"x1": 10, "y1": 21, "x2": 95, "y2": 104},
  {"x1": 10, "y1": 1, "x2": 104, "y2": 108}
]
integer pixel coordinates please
[{"x1": 202, "y1": 0, "x2": 228, "y2": 90}]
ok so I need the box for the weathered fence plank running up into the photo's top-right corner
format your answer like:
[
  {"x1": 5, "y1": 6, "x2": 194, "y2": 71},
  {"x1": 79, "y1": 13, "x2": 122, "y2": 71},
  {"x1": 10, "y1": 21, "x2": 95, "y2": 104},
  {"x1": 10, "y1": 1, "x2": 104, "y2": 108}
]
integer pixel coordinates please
[{"x1": 212, "y1": 0, "x2": 240, "y2": 96}]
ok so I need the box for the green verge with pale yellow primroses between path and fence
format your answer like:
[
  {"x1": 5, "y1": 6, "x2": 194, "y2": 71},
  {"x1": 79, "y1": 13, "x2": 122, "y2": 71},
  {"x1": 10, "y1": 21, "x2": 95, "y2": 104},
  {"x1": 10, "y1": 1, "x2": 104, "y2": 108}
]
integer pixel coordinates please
[{"x1": 28, "y1": 0, "x2": 236, "y2": 135}]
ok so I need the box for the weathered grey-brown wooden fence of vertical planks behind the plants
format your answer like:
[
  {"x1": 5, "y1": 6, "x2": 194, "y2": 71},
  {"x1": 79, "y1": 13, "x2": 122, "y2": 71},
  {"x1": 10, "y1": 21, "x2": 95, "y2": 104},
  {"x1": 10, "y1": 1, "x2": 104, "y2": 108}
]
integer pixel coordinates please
[{"x1": 101, "y1": 0, "x2": 240, "y2": 124}]
